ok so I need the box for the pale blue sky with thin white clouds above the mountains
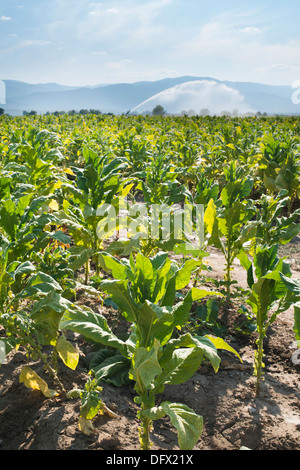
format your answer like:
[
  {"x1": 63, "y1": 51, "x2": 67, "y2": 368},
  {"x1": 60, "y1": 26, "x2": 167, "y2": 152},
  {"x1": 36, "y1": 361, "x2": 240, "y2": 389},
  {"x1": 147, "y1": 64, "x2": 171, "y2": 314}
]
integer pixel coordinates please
[{"x1": 0, "y1": 0, "x2": 300, "y2": 86}]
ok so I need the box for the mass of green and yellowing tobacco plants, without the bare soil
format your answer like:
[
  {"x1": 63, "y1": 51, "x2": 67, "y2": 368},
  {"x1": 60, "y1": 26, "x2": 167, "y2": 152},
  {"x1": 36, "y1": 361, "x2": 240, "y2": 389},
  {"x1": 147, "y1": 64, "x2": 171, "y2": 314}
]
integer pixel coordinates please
[{"x1": 0, "y1": 115, "x2": 300, "y2": 449}]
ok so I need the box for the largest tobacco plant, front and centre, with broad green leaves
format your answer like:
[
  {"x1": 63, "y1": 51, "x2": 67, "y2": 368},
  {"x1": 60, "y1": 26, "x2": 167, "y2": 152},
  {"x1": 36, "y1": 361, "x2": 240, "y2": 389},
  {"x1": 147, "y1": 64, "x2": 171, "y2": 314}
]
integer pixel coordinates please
[{"x1": 60, "y1": 252, "x2": 240, "y2": 450}]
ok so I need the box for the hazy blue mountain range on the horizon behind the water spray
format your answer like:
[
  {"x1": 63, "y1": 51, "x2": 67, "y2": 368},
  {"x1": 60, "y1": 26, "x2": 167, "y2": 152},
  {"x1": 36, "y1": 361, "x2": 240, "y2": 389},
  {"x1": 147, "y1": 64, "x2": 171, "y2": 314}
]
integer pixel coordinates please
[{"x1": 0, "y1": 76, "x2": 300, "y2": 115}]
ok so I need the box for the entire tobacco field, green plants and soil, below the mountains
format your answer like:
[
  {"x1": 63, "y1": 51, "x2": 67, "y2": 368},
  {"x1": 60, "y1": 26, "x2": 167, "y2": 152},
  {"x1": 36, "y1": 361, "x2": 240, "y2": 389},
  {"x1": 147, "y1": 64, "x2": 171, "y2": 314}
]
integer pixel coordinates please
[{"x1": 0, "y1": 113, "x2": 300, "y2": 451}]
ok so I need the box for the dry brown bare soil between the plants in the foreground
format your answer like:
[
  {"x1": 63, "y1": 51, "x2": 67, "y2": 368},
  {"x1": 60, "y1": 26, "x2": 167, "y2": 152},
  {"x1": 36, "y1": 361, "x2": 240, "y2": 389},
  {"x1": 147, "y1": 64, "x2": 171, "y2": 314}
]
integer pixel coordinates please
[{"x1": 0, "y1": 239, "x2": 300, "y2": 452}]
